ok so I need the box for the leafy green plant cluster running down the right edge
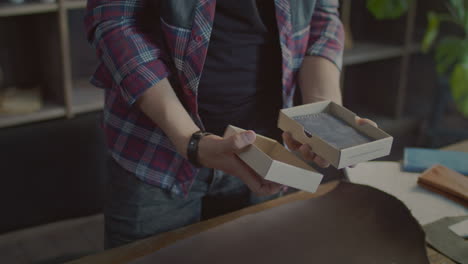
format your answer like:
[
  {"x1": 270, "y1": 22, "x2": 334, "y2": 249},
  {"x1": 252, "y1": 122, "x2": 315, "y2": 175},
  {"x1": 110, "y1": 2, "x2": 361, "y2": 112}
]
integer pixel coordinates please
[{"x1": 422, "y1": 0, "x2": 468, "y2": 116}]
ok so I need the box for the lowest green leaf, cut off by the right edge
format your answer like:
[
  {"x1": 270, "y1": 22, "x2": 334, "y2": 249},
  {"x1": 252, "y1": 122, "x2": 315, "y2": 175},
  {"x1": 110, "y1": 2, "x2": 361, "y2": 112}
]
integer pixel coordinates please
[{"x1": 450, "y1": 63, "x2": 468, "y2": 117}]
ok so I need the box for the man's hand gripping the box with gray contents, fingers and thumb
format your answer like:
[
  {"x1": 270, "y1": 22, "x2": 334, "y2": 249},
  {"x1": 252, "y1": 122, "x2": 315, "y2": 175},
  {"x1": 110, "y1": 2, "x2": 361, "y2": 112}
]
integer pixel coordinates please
[{"x1": 283, "y1": 117, "x2": 377, "y2": 168}]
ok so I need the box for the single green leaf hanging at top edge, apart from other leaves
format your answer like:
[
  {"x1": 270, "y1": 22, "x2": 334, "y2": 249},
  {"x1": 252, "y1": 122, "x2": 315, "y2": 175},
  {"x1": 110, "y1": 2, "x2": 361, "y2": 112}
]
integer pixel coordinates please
[{"x1": 366, "y1": 0, "x2": 413, "y2": 19}]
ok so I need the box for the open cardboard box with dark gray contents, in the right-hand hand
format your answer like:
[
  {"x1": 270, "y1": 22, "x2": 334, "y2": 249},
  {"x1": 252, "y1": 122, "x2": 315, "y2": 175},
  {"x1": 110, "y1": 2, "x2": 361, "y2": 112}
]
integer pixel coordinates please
[{"x1": 278, "y1": 101, "x2": 393, "y2": 169}]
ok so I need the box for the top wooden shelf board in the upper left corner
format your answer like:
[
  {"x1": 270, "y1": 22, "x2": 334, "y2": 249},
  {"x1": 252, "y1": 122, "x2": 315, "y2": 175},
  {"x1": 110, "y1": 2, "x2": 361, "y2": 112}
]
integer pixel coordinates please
[{"x1": 0, "y1": 2, "x2": 58, "y2": 17}]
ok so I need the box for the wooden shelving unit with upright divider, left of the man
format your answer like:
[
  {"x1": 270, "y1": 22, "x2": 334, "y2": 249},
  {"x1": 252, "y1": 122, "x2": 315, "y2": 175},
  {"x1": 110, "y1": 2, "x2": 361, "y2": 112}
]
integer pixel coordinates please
[{"x1": 0, "y1": 0, "x2": 97, "y2": 128}]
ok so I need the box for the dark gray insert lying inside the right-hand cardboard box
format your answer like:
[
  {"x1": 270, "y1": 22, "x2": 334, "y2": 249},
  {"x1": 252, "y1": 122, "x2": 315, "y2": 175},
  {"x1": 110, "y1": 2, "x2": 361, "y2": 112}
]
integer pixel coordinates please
[{"x1": 293, "y1": 112, "x2": 372, "y2": 149}]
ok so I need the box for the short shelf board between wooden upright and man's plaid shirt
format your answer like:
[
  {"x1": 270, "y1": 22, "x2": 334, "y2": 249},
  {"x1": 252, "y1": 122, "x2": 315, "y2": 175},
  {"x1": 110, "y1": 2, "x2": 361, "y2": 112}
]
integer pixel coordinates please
[{"x1": 72, "y1": 79, "x2": 104, "y2": 114}]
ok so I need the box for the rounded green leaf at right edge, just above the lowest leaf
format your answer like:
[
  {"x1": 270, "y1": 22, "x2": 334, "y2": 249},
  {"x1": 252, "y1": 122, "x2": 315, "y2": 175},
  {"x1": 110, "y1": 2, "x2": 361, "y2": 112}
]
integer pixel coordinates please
[{"x1": 435, "y1": 37, "x2": 468, "y2": 74}]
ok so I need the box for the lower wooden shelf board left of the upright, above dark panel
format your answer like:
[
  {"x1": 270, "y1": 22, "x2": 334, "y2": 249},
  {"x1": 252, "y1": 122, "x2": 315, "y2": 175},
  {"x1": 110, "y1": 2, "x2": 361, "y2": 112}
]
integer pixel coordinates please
[{"x1": 0, "y1": 103, "x2": 65, "y2": 128}]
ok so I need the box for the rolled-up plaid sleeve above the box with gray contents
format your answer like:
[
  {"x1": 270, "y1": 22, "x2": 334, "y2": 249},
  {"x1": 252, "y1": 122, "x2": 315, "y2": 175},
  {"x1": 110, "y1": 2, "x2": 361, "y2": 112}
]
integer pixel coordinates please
[{"x1": 306, "y1": 0, "x2": 345, "y2": 70}]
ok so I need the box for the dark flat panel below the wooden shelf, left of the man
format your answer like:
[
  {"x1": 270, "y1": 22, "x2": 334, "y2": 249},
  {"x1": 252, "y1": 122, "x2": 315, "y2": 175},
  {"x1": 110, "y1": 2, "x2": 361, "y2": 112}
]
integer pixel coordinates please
[{"x1": 0, "y1": 113, "x2": 106, "y2": 233}]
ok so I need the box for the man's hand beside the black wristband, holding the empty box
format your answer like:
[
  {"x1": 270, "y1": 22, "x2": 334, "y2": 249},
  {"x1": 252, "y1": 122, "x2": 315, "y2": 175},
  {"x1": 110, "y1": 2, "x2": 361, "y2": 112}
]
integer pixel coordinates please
[{"x1": 198, "y1": 130, "x2": 281, "y2": 196}]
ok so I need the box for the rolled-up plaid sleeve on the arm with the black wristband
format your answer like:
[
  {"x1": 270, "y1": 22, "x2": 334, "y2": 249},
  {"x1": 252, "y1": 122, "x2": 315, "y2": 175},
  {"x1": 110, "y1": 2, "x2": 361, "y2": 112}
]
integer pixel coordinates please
[{"x1": 85, "y1": 0, "x2": 169, "y2": 105}]
